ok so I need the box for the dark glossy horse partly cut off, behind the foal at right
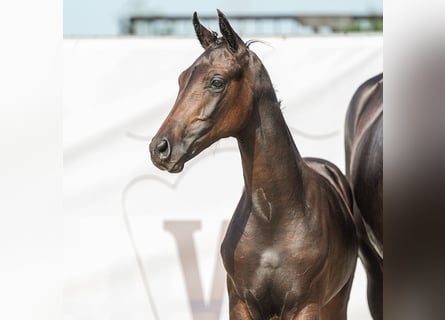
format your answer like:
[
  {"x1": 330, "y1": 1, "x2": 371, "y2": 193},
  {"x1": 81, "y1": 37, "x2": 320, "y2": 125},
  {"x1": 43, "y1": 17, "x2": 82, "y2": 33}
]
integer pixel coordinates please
[{"x1": 345, "y1": 74, "x2": 383, "y2": 320}]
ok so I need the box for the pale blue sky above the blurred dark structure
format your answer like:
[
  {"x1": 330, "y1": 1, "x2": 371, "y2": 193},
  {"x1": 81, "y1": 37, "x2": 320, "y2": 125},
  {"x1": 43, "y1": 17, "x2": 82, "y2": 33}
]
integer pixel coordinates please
[{"x1": 63, "y1": 0, "x2": 383, "y2": 36}]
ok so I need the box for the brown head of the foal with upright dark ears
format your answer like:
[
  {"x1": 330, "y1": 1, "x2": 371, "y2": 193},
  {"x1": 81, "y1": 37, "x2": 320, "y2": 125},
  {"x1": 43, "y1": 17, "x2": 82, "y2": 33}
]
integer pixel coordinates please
[{"x1": 150, "y1": 11, "x2": 259, "y2": 172}]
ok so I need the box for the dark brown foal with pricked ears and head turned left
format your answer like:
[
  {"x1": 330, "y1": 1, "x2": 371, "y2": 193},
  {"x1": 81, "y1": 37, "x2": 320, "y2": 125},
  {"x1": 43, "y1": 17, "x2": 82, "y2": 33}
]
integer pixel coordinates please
[{"x1": 150, "y1": 11, "x2": 357, "y2": 320}]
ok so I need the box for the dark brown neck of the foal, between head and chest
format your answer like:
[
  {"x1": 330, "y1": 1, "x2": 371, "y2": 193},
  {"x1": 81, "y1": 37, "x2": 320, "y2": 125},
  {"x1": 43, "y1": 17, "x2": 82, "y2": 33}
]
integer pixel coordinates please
[{"x1": 237, "y1": 62, "x2": 305, "y2": 212}]
